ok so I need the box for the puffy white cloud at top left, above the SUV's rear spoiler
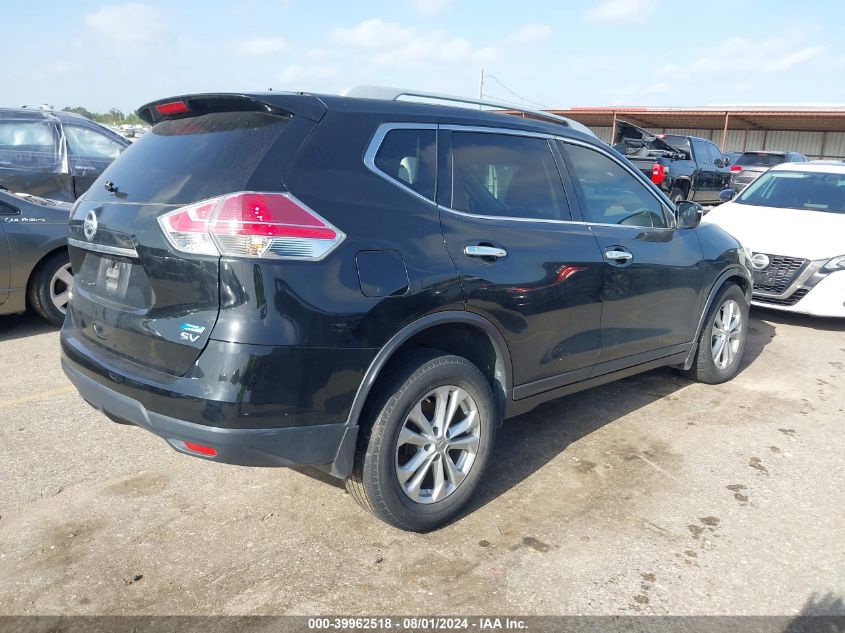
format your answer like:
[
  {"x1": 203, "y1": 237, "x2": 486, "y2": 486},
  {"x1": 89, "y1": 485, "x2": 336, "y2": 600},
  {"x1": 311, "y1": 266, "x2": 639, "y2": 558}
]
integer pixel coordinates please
[{"x1": 82, "y1": 3, "x2": 166, "y2": 45}]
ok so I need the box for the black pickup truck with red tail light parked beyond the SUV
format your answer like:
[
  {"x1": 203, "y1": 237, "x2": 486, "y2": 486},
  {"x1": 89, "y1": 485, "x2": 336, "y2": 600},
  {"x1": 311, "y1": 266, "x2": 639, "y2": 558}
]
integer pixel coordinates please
[{"x1": 613, "y1": 121, "x2": 731, "y2": 204}]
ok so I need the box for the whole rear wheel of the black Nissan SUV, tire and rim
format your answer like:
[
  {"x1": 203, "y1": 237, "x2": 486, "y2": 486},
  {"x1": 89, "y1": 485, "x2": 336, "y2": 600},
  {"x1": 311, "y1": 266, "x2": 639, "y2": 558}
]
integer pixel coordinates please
[{"x1": 346, "y1": 350, "x2": 497, "y2": 532}]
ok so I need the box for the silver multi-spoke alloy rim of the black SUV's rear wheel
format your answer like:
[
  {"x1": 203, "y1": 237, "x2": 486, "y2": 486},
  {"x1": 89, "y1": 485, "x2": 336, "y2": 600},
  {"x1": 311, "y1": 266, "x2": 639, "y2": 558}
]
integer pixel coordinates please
[{"x1": 396, "y1": 385, "x2": 481, "y2": 503}]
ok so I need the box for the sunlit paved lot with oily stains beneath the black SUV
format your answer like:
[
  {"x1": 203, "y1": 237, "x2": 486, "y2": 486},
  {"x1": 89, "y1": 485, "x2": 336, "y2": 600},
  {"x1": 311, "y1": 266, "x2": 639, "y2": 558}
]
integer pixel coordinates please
[{"x1": 0, "y1": 311, "x2": 845, "y2": 615}]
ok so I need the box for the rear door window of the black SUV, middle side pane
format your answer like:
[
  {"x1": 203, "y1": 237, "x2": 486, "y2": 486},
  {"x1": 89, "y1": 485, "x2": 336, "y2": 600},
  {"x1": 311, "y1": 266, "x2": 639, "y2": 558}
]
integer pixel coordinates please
[{"x1": 452, "y1": 132, "x2": 570, "y2": 220}]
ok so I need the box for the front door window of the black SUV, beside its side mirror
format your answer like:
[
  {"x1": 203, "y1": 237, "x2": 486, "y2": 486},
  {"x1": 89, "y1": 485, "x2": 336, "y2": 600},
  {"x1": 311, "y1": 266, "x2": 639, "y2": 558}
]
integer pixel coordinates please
[{"x1": 565, "y1": 144, "x2": 667, "y2": 227}]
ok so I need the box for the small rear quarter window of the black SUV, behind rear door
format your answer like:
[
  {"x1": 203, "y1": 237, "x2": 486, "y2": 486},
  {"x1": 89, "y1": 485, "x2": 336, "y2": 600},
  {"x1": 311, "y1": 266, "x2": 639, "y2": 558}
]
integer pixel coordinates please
[{"x1": 375, "y1": 130, "x2": 437, "y2": 200}]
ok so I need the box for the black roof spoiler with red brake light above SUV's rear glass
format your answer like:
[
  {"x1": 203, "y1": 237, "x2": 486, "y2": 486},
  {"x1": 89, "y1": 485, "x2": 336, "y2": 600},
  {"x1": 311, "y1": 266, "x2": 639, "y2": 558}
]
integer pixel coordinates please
[{"x1": 137, "y1": 92, "x2": 326, "y2": 125}]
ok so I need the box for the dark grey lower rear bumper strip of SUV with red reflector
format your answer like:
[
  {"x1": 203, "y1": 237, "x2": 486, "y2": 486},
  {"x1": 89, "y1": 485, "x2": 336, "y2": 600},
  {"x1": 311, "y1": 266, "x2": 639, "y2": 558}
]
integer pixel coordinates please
[{"x1": 62, "y1": 357, "x2": 358, "y2": 477}]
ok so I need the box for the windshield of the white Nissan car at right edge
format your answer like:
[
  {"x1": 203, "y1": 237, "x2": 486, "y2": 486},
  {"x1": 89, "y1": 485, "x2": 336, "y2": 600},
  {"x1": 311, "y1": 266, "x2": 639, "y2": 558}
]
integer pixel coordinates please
[{"x1": 736, "y1": 170, "x2": 845, "y2": 213}]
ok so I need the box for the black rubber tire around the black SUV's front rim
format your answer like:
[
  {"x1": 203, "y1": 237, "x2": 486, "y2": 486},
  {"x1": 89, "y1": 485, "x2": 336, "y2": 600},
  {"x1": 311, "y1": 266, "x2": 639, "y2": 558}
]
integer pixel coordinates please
[{"x1": 686, "y1": 283, "x2": 748, "y2": 385}]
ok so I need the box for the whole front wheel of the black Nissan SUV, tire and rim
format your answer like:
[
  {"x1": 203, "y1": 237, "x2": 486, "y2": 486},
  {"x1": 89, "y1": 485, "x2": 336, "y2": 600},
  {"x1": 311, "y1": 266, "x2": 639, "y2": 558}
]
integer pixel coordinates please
[{"x1": 687, "y1": 283, "x2": 748, "y2": 385}]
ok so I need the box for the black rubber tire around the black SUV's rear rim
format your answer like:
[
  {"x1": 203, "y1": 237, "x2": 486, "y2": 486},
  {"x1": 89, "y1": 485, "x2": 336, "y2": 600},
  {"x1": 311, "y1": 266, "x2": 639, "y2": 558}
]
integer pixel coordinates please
[{"x1": 346, "y1": 349, "x2": 498, "y2": 532}]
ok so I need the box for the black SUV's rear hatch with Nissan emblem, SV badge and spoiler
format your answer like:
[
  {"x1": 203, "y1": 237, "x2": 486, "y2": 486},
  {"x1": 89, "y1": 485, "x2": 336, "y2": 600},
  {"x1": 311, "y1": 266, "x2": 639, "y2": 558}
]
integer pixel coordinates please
[{"x1": 69, "y1": 95, "x2": 322, "y2": 375}]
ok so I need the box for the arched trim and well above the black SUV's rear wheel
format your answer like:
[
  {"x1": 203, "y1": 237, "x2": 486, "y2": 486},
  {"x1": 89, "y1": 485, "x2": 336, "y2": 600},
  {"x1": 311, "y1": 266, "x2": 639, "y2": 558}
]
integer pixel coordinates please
[{"x1": 347, "y1": 310, "x2": 513, "y2": 426}]
